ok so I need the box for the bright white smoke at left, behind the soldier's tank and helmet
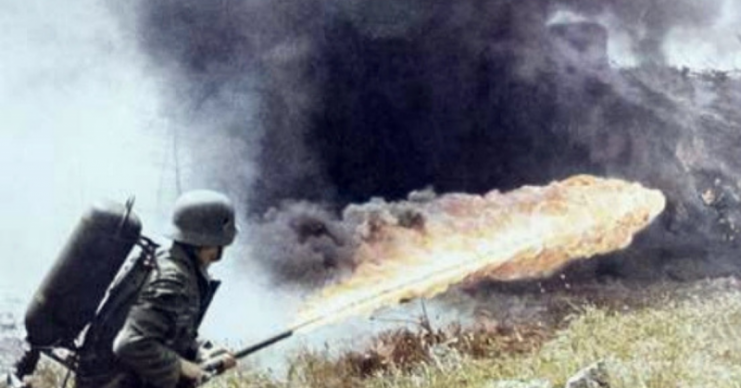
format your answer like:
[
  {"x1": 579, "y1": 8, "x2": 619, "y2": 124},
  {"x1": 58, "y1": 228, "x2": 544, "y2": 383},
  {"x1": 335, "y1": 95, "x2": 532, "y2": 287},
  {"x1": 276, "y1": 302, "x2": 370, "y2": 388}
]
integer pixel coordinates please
[{"x1": 0, "y1": 0, "x2": 286, "y2": 348}]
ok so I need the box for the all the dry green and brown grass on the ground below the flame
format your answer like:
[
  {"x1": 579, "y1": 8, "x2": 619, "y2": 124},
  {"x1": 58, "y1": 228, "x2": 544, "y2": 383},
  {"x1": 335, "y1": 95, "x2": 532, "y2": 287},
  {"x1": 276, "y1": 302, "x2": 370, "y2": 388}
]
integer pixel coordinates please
[{"x1": 18, "y1": 279, "x2": 741, "y2": 388}]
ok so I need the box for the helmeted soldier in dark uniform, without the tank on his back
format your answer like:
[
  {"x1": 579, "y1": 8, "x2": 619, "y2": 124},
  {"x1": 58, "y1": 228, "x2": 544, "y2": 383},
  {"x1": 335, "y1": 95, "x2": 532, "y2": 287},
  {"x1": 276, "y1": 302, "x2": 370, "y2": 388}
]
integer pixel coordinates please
[{"x1": 77, "y1": 190, "x2": 237, "y2": 388}]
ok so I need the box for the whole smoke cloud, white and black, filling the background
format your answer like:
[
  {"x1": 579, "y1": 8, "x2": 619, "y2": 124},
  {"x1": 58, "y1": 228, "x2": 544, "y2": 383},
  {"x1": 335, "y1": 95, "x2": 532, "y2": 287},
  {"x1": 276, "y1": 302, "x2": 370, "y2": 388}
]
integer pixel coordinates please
[{"x1": 0, "y1": 0, "x2": 741, "y2": 372}]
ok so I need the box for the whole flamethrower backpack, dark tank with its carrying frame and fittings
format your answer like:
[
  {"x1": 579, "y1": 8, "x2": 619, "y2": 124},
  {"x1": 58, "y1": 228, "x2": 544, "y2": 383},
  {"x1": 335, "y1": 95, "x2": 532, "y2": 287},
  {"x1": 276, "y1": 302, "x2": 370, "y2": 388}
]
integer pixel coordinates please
[{"x1": 7, "y1": 198, "x2": 158, "y2": 387}]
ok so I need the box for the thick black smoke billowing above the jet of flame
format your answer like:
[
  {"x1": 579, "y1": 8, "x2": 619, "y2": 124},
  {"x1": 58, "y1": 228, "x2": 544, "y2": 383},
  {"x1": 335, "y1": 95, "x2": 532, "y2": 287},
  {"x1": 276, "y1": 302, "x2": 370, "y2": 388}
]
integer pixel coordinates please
[{"x1": 125, "y1": 0, "x2": 741, "y2": 284}]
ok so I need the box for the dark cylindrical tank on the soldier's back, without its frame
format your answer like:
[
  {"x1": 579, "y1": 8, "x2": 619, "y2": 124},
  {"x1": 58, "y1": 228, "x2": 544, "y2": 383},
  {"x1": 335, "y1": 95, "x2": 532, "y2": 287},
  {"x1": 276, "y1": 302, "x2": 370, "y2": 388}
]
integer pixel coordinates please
[{"x1": 25, "y1": 202, "x2": 142, "y2": 347}]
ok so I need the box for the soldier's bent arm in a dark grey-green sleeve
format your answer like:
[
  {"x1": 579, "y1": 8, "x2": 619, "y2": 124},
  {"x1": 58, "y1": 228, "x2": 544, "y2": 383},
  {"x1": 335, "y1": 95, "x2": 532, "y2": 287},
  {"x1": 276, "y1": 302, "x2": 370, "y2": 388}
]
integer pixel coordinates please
[{"x1": 113, "y1": 276, "x2": 194, "y2": 388}]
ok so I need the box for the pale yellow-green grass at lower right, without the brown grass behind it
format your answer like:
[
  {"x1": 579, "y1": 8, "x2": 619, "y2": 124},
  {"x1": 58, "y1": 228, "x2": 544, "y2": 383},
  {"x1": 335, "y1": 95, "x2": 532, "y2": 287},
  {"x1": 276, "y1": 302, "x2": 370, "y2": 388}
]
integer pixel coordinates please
[{"x1": 227, "y1": 284, "x2": 741, "y2": 388}]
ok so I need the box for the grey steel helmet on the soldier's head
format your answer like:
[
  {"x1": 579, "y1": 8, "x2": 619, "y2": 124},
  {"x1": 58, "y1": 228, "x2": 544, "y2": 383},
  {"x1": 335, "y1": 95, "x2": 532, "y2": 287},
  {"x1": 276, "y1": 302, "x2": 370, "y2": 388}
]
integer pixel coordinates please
[{"x1": 169, "y1": 190, "x2": 237, "y2": 247}]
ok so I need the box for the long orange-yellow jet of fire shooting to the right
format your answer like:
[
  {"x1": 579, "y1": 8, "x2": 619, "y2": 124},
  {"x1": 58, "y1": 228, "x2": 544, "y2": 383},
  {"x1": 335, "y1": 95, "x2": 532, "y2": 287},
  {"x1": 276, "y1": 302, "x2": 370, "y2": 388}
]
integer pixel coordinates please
[{"x1": 296, "y1": 175, "x2": 665, "y2": 330}]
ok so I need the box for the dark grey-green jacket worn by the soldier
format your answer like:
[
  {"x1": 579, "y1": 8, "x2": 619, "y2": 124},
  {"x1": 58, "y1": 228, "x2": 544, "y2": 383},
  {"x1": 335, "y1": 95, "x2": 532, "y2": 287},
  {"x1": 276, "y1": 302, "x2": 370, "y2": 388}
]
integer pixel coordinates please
[{"x1": 78, "y1": 244, "x2": 218, "y2": 388}]
